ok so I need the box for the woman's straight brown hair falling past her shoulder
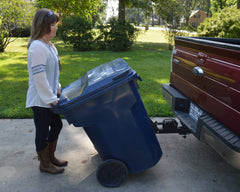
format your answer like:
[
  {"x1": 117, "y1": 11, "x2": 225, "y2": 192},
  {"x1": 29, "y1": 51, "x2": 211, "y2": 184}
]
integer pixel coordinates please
[{"x1": 27, "y1": 8, "x2": 59, "y2": 48}]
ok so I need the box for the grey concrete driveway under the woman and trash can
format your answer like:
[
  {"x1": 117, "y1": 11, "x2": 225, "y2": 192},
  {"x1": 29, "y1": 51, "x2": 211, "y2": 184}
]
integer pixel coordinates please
[{"x1": 0, "y1": 119, "x2": 240, "y2": 192}]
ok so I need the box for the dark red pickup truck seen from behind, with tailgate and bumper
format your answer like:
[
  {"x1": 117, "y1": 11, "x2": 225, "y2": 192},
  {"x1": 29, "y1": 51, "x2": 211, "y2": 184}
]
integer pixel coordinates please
[{"x1": 162, "y1": 37, "x2": 240, "y2": 169}]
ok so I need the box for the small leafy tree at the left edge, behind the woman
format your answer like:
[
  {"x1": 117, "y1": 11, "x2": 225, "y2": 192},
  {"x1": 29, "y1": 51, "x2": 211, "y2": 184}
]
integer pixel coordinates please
[{"x1": 0, "y1": 0, "x2": 34, "y2": 52}]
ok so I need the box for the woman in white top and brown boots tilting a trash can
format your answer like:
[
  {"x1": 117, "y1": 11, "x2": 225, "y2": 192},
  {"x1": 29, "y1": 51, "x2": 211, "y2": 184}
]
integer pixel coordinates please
[{"x1": 26, "y1": 9, "x2": 68, "y2": 174}]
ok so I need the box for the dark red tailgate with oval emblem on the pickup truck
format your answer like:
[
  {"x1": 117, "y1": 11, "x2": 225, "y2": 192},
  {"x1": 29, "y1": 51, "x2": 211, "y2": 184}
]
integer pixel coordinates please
[{"x1": 170, "y1": 37, "x2": 240, "y2": 136}]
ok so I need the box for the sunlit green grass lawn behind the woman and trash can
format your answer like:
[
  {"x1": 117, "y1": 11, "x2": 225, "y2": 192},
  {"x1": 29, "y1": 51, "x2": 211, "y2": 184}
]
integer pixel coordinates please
[{"x1": 0, "y1": 30, "x2": 172, "y2": 118}]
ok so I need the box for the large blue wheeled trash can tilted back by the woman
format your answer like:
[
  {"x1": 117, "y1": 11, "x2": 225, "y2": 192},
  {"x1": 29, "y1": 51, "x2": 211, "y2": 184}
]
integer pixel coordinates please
[{"x1": 53, "y1": 58, "x2": 162, "y2": 187}]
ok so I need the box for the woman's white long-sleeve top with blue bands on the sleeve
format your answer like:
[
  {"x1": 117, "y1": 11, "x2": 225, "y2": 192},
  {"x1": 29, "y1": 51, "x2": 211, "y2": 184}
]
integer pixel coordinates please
[{"x1": 26, "y1": 40, "x2": 60, "y2": 108}]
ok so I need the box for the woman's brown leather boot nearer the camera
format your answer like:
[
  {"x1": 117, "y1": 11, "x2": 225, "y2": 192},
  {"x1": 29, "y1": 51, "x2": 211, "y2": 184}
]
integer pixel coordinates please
[{"x1": 37, "y1": 146, "x2": 64, "y2": 174}]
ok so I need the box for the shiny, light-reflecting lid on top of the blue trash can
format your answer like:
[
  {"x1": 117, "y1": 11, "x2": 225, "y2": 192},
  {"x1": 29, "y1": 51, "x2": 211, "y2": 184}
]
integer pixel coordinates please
[{"x1": 60, "y1": 58, "x2": 136, "y2": 101}]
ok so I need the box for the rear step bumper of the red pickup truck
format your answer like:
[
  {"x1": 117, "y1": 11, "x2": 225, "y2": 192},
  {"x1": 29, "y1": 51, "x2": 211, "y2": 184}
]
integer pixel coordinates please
[{"x1": 162, "y1": 84, "x2": 240, "y2": 169}]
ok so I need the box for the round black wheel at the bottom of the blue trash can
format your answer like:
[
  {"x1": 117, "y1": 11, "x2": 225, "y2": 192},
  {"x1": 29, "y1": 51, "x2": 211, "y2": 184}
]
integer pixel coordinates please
[{"x1": 97, "y1": 159, "x2": 128, "y2": 187}]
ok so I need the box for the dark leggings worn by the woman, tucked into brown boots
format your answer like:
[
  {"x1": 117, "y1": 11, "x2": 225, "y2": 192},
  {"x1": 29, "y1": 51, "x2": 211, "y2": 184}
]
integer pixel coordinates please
[{"x1": 32, "y1": 107, "x2": 62, "y2": 152}]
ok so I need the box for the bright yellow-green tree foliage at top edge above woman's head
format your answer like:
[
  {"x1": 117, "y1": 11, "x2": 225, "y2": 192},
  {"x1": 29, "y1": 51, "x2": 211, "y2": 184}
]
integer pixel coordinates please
[{"x1": 36, "y1": 0, "x2": 102, "y2": 17}]
